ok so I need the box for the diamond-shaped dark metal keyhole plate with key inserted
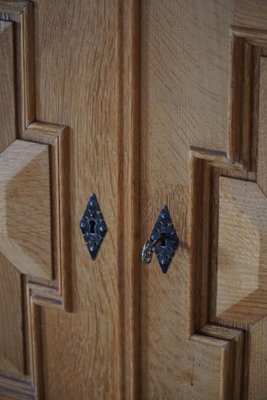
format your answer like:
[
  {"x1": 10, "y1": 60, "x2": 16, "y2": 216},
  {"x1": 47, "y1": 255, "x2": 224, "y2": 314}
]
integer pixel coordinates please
[{"x1": 142, "y1": 205, "x2": 179, "y2": 273}]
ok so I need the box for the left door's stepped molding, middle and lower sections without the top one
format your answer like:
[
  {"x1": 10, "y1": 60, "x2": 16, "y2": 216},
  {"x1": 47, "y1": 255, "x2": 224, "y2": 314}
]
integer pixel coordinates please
[{"x1": 0, "y1": 122, "x2": 72, "y2": 399}]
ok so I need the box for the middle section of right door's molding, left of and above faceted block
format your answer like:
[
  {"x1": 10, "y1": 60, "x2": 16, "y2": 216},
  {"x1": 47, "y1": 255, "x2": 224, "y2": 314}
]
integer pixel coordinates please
[{"x1": 189, "y1": 148, "x2": 255, "y2": 335}]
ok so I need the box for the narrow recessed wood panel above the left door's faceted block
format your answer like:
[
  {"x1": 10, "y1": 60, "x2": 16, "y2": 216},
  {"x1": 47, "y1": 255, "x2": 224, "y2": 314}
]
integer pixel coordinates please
[{"x1": 0, "y1": 20, "x2": 16, "y2": 150}]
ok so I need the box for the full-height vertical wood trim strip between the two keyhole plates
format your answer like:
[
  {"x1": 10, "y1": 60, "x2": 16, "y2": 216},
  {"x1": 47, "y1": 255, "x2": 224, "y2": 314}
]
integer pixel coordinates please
[{"x1": 118, "y1": 0, "x2": 140, "y2": 400}]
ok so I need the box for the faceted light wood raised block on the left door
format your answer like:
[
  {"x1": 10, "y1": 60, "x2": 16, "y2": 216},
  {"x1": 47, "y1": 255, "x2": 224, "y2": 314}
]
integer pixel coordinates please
[{"x1": 0, "y1": 140, "x2": 52, "y2": 279}]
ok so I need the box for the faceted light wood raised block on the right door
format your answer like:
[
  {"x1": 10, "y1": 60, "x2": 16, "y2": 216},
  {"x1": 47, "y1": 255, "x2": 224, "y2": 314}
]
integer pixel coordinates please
[{"x1": 216, "y1": 177, "x2": 267, "y2": 323}]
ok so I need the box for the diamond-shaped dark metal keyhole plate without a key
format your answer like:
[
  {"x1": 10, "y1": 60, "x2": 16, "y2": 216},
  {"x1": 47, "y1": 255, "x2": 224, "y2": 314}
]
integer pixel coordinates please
[{"x1": 80, "y1": 193, "x2": 107, "y2": 260}]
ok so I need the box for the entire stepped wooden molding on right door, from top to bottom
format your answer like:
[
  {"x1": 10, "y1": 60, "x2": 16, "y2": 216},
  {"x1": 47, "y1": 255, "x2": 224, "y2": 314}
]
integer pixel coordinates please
[{"x1": 189, "y1": 27, "x2": 267, "y2": 399}]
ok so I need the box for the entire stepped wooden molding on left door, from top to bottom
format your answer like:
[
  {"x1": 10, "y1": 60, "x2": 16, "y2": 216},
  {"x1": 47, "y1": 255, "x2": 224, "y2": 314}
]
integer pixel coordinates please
[{"x1": 0, "y1": 0, "x2": 72, "y2": 399}]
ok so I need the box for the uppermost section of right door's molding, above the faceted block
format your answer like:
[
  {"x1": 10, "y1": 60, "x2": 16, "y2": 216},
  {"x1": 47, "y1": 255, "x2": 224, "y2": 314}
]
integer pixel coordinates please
[{"x1": 227, "y1": 26, "x2": 267, "y2": 172}]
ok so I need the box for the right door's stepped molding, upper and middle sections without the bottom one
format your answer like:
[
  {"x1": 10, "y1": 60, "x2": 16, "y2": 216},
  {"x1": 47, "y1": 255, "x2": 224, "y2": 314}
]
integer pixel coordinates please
[{"x1": 189, "y1": 27, "x2": 267, "y2": 334}]
